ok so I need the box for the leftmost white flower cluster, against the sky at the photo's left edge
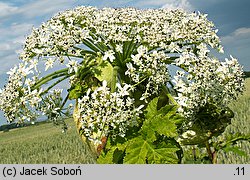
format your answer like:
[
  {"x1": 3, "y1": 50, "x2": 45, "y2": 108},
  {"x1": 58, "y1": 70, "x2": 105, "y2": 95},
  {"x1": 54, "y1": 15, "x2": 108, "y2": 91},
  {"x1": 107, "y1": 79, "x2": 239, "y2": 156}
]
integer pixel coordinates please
[{"x1": 0, "y1": 60, "x2": 68, "y2": 123}]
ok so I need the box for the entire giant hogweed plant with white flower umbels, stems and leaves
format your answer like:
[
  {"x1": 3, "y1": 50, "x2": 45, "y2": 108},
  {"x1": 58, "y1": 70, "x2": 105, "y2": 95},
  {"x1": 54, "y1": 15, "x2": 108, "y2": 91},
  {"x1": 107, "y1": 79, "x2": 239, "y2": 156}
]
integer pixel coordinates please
[{"x1": 0, "y1": 7, "x2": 249, "y2": 164}]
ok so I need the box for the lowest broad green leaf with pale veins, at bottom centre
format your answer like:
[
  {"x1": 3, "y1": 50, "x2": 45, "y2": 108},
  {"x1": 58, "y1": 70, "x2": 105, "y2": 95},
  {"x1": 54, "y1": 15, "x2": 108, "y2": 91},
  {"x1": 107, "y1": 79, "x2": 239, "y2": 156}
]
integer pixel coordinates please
[{"x1": 124, "y1": 136, "x2": 179, "y2": 164}]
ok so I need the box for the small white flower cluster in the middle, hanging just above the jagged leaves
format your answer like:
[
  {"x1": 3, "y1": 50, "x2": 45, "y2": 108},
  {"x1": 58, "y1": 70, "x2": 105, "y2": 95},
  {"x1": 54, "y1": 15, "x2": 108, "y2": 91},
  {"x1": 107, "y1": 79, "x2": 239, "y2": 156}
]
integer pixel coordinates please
[{"x1": 125, "y1": 46, "x2": 170, "y2": 100}]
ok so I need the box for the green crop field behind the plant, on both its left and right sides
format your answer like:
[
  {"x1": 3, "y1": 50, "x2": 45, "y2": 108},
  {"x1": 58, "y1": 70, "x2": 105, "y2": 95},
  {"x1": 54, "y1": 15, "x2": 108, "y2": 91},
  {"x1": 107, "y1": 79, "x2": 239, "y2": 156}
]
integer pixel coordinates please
[{"x1": 0, "y1": 78, "x2": 250, "y2": 164}]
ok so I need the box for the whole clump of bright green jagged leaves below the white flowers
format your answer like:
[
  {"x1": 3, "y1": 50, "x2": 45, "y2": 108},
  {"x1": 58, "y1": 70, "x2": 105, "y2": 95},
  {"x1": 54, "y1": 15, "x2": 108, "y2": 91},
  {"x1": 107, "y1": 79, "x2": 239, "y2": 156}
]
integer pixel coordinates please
[{"x1": 98, "y1": 98, "x2": 181, "y2": 164}]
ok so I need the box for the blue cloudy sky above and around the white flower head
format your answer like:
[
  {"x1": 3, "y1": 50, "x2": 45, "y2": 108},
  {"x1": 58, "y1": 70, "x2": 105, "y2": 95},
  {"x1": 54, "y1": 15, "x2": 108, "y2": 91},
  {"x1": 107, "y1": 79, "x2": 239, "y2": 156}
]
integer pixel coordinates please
[{"x1": 0, "y1": 0, "x2": 250, "y2": 124}]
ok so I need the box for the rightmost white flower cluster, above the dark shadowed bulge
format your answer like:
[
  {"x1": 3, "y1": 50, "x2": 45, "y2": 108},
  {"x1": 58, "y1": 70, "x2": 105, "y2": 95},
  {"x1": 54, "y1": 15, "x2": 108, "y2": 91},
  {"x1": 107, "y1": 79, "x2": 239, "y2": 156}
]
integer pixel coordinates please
[{"x1": 173, "y1": 44, "x2": 244, "y2": 117}]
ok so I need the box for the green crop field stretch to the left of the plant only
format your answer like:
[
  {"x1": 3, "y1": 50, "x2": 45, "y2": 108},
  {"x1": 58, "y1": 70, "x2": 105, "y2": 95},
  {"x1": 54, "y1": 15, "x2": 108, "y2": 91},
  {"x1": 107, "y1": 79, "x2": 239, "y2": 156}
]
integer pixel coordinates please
[{"x1": 0, "y1": 120, "x2": 94, "y2": 164}]
